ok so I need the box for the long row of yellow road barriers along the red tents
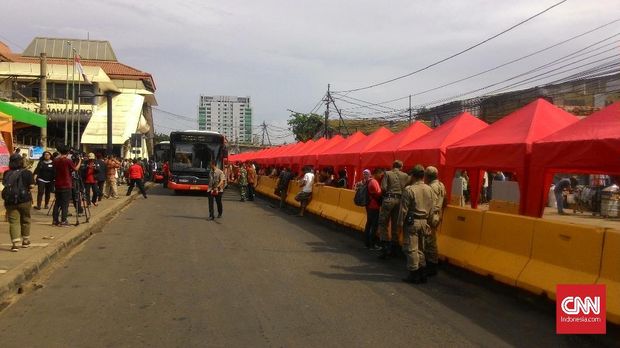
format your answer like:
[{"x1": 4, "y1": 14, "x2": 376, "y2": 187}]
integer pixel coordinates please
[{"x1": 257, "y1": 177, "x2": 620, "y2": 324}]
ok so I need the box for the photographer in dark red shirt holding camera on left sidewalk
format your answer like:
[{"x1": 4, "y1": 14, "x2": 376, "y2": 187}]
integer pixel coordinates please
[{"x1": 52, "y1": 145, "x2": 82, "y2": 226}]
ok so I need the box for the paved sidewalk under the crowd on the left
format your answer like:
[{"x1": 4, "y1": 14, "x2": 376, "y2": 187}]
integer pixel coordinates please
[{"x1": 0, "y1": 182, "x2": 156, "y2": 303}]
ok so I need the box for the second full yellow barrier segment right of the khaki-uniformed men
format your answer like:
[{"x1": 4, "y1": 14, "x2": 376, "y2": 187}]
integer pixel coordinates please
[{"x1": 468, "y1": 211, "x2": 536, "y2": 286}]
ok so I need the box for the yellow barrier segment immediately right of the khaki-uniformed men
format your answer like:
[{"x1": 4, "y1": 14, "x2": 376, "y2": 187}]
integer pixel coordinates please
[{"x1": 437, "y1": 205, "x2": 484, "y2": 267}]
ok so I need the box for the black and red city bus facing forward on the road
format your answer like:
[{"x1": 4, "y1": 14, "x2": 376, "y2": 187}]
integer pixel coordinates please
[{"x1": 168, "y1": 130, "x2": 228, "y2": 192}]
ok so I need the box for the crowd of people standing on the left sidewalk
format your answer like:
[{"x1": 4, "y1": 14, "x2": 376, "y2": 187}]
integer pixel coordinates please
[{"x1": 2, "y1": 145, "x2": 153, "y2": 252}]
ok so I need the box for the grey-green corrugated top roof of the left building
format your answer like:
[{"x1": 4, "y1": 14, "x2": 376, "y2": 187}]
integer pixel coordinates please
[{"x1": 22, "y1": 37, "x2": 116, "y2": 61}]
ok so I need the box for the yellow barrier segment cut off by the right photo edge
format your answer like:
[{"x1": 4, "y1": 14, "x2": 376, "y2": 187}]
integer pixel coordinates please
[{"x1": 596, "y1": 229, "x2": 620, "y2": 324}]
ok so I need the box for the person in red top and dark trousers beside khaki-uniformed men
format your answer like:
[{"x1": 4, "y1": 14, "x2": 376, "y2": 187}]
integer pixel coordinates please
[{"x1": 361, "y1": 168, "x2": 383, "y2": 250}]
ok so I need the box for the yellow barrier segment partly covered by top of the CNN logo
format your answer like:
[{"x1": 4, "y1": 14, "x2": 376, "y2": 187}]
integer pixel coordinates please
[{"x1": 517, "y1": 219, "x2": 604, "y2": 299}]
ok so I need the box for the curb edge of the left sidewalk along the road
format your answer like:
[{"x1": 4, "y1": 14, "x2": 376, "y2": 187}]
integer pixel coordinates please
[{"x1": 0, "y1": 183, "x2": 154, "y2": 304}]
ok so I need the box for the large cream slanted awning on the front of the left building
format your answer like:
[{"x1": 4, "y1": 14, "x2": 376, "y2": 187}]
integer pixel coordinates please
[{"x1": 82, "y1": 94, "x2": 144, "y2": 145}]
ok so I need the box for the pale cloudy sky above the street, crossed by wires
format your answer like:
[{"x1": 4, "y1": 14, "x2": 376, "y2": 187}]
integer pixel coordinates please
[{"x1": 0, "y1": 0, "x2": 620, "y2": 143}]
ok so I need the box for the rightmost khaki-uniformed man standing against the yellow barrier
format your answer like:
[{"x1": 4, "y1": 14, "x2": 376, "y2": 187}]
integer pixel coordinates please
[{"x1": 424, "y1": 166, "x2": 447, "y2": 277}]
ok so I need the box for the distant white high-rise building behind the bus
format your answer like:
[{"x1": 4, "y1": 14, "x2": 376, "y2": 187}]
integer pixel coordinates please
[{"x1": 198, "y1": 95, "x2": 252, "y2": 143}]
